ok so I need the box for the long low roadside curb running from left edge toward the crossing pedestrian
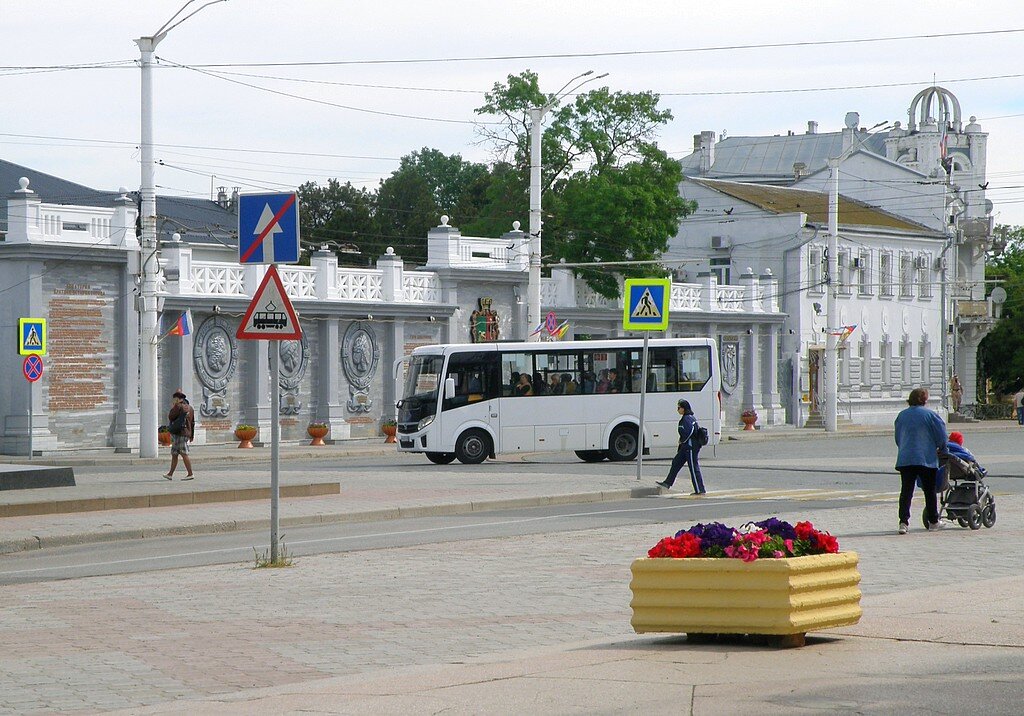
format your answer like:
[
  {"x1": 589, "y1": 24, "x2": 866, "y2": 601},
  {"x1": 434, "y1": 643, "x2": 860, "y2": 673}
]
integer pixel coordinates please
[{"x1": 0, "y1": 488, "x2": 660, "y2": 554}]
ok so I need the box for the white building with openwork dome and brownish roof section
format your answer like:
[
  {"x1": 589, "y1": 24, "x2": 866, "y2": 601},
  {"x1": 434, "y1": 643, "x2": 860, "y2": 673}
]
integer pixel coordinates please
[{"x1": 669, "y1": 87, "x2": 996, "y2": 426}]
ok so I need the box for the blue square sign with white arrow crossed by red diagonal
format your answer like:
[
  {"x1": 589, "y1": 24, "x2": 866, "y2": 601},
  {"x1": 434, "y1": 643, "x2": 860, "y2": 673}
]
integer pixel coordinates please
[{"x1": 239, "y1": 192, "x2": 299, "y2": 263}]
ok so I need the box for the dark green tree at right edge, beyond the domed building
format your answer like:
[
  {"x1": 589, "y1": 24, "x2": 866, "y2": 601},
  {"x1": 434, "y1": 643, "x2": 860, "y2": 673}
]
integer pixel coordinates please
[{"x1": 978, "y1": 225, "x2": 1024, "y2": 394}]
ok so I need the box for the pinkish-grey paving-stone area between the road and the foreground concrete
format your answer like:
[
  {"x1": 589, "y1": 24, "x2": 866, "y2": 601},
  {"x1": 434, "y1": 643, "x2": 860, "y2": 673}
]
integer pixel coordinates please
[{"x1": 0, "y1": 496, "x2": 1024, "y2": 714}]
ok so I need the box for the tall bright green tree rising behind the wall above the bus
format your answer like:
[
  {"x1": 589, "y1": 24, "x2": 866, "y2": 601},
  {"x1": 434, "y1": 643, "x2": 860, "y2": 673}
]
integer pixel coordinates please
[{"x1": 469, "y1": 71, "x2": 695, "y2": 297}]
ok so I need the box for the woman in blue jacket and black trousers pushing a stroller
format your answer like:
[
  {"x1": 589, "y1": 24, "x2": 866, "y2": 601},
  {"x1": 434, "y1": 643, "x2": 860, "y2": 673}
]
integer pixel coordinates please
[{"x1": 895, "y1": 388, "x2": 946, "y2": 535}]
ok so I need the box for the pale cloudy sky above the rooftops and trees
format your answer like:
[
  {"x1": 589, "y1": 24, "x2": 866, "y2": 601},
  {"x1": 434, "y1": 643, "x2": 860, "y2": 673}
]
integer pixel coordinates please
[{"x1": 6, "y1": 0, "x2": 1024, "y2": 225}]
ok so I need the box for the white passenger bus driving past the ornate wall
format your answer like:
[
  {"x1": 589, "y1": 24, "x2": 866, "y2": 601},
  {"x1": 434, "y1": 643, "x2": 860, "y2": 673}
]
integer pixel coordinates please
[{"x1": 397, "y1": 338, "x2": 722, "y2": 465}]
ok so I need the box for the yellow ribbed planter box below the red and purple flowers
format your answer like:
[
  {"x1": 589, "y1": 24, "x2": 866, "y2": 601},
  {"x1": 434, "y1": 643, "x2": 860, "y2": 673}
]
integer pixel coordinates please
[{"x1": 630, "y1": 552, "x2": 861, "y2": 645}]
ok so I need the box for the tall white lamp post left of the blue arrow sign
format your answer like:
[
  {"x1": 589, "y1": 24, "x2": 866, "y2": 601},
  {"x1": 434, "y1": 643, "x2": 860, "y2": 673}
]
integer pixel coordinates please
[{"x1": 135, "y1": 0, "x2": 226, "y2": 458}]
